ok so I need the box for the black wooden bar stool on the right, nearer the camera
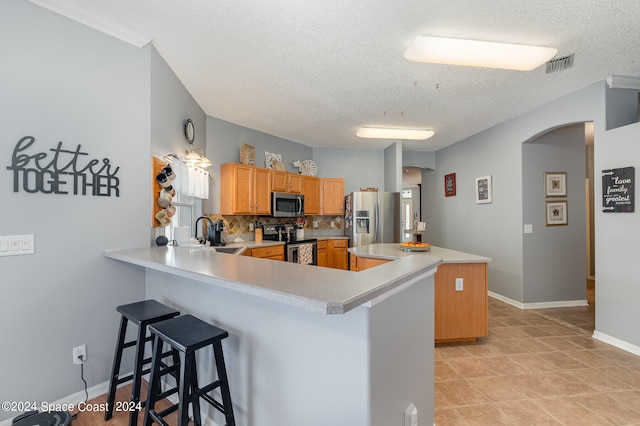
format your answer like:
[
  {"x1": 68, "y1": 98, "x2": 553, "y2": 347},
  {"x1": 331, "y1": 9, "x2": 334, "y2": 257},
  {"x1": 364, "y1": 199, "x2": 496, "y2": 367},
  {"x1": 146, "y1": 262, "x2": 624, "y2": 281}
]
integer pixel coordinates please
[{"x1": 144, "y1": 315, "x2": 236, "y2": 426}]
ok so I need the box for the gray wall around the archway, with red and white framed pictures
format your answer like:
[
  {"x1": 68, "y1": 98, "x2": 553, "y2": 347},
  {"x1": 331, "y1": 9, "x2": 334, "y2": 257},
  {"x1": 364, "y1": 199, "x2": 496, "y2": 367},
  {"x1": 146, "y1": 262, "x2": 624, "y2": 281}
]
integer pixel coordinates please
[{"x1": 422, "y1": 82, "x2": 605, "y2": 302}]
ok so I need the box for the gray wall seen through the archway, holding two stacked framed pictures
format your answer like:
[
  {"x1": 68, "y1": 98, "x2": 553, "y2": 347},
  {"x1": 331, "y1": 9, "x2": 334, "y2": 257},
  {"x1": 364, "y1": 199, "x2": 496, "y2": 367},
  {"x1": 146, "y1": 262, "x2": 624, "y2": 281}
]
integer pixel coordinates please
[{"x1": 522, "y1": 124, "x2": 586, "y2": 303}]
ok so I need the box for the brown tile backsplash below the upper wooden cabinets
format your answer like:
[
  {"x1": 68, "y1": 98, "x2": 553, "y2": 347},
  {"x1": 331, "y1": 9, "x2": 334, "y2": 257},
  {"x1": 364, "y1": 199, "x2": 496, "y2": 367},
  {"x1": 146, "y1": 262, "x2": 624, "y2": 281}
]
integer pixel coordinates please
[{"x1": 206, "y1": 214, "x2": 344, "y2": 235}]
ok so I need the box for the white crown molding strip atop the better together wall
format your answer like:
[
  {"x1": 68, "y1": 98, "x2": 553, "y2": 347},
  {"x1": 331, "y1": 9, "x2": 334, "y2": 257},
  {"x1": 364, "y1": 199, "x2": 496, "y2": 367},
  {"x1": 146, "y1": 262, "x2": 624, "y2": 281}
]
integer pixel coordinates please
[{"x1": 27, "y1": 0, "x2": 153, "y2": 48}]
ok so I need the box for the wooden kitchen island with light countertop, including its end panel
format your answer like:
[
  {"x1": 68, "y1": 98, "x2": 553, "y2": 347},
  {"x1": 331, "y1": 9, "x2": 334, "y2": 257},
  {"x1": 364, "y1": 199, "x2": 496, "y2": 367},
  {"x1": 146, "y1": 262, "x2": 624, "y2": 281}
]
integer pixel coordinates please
[{"x1": 349, "y1": 244, "x2": 491, "y2": 343}]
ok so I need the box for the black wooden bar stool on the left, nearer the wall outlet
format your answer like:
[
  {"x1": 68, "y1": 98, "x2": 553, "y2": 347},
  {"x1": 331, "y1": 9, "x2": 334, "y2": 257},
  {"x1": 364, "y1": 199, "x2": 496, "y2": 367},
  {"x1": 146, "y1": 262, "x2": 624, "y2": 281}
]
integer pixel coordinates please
[{"x1": 104, "y1": 299, "x2": 180, "y2": 425}]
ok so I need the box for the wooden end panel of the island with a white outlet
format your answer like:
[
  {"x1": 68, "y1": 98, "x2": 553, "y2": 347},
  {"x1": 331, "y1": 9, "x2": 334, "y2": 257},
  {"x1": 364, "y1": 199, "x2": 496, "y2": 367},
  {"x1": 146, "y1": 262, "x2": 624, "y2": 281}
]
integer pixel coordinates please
[{"x1": 434, "y1": 263, "x2": 489, "y2": 343}]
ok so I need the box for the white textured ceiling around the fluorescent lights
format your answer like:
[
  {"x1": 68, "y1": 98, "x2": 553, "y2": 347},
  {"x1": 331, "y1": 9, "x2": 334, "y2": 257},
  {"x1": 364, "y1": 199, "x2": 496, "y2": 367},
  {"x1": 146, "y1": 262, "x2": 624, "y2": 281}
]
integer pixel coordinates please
[{"x1": 31, "y1": 0, "x2": 640, "y2": 151}]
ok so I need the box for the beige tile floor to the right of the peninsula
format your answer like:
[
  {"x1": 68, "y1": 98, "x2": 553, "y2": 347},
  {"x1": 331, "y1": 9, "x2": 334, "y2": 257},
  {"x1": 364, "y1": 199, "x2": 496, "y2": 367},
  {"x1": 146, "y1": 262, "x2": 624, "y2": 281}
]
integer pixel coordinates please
[{"x1": 435, "y1": 292, "x2": 640, "y2": 426}]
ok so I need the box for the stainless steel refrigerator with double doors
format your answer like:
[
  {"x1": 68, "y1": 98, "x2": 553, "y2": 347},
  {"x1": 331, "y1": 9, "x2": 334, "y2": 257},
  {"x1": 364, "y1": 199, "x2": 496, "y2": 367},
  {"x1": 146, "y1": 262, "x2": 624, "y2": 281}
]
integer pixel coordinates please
[{"x1": 344, "y1": 192, "x2": 402, "y2": 247}]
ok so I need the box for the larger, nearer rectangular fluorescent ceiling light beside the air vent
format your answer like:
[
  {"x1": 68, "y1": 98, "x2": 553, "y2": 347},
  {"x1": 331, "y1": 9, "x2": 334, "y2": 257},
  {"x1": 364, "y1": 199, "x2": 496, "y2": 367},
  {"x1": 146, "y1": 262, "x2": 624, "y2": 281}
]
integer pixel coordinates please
[{"x1": 404, "y1": 36, "x2": 558, "y2": 71}]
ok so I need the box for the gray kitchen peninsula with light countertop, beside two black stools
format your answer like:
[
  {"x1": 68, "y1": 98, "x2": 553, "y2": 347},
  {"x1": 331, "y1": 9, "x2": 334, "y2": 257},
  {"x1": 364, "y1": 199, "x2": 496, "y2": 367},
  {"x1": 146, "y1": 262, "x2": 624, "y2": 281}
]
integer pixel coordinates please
[{"x1": 105, "y1": 243, "x2": 441, "y2": 426}]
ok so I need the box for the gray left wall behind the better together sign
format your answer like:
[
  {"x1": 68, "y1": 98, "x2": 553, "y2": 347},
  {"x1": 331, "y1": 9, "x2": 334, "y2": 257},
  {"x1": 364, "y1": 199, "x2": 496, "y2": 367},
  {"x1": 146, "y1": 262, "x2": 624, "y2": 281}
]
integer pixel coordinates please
[{"x1": 0, "y1": 1, "x2": 151, "y2": 420}]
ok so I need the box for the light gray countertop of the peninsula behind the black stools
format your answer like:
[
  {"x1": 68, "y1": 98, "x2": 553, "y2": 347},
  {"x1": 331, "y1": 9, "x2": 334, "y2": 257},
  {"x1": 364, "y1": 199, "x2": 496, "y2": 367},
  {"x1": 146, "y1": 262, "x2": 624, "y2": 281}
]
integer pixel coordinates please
[{"x1": 104, "y1": 241, "x2": 444, "y2": 314}]
